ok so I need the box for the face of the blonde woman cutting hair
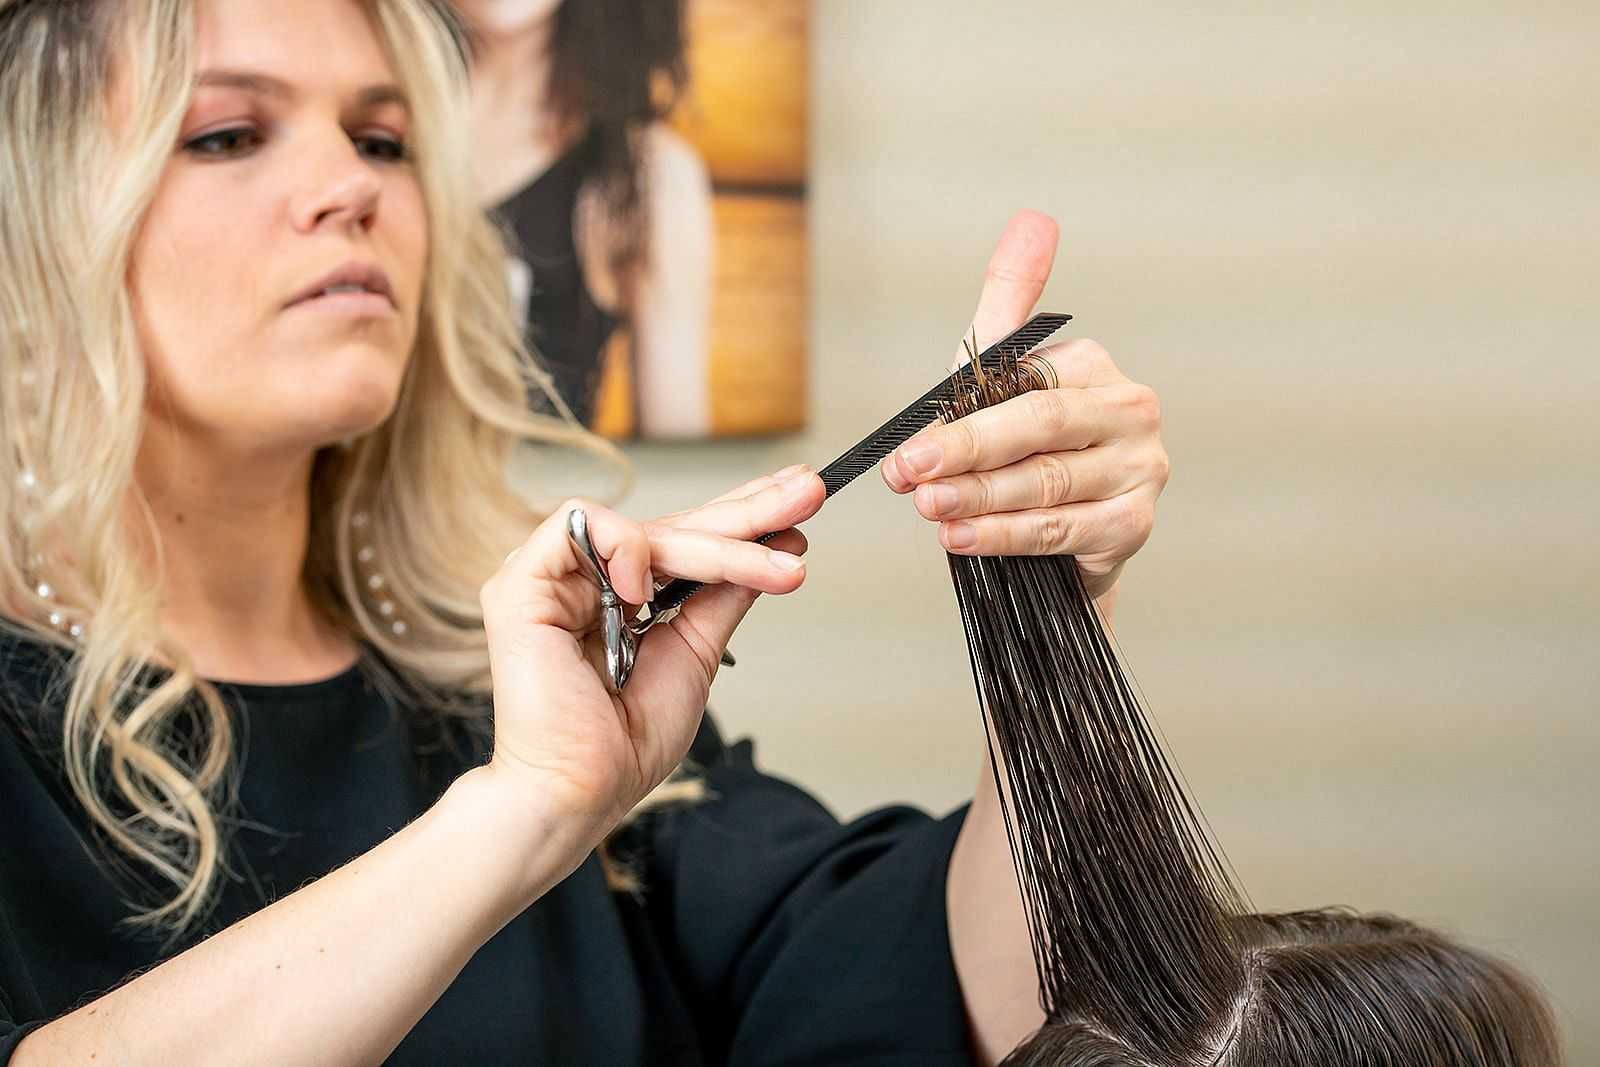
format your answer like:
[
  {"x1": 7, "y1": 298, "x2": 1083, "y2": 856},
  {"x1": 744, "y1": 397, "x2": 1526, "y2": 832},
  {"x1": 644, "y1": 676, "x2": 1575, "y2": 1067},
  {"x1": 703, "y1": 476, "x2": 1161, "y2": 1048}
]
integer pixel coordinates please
[{"x1": 128, "y1": 0, "x2": 427, "y2": 451}]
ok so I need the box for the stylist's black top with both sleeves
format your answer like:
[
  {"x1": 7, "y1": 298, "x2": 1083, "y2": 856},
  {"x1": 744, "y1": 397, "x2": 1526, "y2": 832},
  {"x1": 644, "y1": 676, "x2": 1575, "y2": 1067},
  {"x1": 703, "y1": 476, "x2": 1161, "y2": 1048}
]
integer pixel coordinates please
[{"x1": 0, "y1": 633, "x2": 970, "y2": 1067}]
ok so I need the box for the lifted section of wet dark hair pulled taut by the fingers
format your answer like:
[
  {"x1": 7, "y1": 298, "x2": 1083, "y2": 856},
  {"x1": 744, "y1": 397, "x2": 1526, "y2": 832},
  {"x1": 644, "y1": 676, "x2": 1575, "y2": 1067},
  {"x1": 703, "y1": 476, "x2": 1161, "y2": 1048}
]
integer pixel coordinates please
[{"x1": 946, "y1": 348, "x2": 1248, "y2": 1059}]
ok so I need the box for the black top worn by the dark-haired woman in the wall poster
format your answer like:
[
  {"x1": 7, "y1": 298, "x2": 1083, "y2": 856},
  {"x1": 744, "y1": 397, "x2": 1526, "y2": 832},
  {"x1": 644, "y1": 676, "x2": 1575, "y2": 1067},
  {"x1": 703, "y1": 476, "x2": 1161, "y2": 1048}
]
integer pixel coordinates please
[{"x1": 493, "y1": 138, "x2": 619, "y2": 426}]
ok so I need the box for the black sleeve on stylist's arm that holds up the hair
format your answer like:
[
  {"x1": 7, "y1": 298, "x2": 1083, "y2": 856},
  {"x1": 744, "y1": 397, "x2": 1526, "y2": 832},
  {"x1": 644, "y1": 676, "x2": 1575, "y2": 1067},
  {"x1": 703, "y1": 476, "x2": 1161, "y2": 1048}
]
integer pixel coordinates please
[{"x1": 642, "y1": 716, "x2": 971, "y2": 1067}]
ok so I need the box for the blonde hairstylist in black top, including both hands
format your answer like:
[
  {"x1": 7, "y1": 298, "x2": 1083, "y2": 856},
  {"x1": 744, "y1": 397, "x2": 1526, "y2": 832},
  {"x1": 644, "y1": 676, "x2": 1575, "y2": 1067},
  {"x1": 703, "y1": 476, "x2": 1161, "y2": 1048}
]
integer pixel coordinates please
[{"x1": 0, "y1": 0, "x2": 1166, "y2": 1067}]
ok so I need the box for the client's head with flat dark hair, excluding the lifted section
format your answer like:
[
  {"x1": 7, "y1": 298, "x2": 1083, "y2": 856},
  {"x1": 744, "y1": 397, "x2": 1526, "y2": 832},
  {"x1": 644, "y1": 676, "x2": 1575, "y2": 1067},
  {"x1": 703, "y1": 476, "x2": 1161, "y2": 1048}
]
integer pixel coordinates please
[{"x1": 1005, "y1": 909, "x2": 1560, "y2": 1067}]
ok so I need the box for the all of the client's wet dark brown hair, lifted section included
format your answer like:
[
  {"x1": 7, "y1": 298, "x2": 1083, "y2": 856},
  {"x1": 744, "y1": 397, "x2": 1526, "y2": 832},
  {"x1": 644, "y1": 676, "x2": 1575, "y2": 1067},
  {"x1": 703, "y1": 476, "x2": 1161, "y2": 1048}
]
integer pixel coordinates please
[{"x1": 946, "y1": 347, "x2": 1560, "y2": 1067}]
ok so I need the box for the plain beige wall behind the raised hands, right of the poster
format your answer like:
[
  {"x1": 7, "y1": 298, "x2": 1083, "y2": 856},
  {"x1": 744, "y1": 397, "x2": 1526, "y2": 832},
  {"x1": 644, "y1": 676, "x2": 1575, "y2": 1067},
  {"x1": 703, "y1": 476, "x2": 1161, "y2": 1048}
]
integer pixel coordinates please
[{"x1": 521, "y1": 0, "x2": 1600, "y2": 1065}]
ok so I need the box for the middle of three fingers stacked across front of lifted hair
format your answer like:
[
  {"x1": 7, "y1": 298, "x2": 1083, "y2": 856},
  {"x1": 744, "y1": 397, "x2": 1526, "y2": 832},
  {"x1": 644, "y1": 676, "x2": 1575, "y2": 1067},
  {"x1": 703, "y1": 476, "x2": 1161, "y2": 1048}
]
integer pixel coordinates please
[{"x1": 912, "y1": 445, "x2": 1155, "y2": 520}]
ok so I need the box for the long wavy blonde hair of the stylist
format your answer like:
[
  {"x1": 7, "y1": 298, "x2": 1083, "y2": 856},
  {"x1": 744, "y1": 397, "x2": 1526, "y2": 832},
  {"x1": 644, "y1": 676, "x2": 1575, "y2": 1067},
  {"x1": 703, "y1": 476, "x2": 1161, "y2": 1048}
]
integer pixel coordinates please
[{"x1": 0, "y1": 0, "x2": 678, "y2": 937}]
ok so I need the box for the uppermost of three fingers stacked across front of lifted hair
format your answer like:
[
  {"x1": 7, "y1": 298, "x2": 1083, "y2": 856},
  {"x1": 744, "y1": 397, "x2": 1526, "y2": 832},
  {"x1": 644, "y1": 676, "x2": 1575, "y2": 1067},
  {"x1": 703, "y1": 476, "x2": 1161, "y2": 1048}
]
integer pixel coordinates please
[{"x1": 883, "y1": 386, "x2": 1144, "y2": 493}]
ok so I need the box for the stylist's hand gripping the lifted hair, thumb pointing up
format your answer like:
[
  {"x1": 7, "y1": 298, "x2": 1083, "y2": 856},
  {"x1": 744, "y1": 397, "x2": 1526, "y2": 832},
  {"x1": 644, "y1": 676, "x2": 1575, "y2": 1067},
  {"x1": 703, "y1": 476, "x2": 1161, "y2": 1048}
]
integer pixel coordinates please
[{"x1": 883, "y1": 211, "x2": 1168, "y2": 597}]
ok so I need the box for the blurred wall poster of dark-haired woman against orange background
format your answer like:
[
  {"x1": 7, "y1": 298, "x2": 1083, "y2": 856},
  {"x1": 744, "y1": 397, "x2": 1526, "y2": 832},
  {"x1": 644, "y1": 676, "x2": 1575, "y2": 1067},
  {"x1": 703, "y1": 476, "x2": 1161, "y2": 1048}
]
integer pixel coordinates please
[{"x1": 456, "y1": 0, "x2": 808, "y2": 438}]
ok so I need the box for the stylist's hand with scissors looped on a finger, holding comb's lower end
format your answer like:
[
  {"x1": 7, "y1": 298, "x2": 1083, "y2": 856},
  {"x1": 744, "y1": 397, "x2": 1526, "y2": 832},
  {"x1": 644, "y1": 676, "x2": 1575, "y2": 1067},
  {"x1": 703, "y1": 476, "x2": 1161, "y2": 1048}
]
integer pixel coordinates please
[{"x1": 482, "y1": 467, "x2": 824, "y2": 843}]
